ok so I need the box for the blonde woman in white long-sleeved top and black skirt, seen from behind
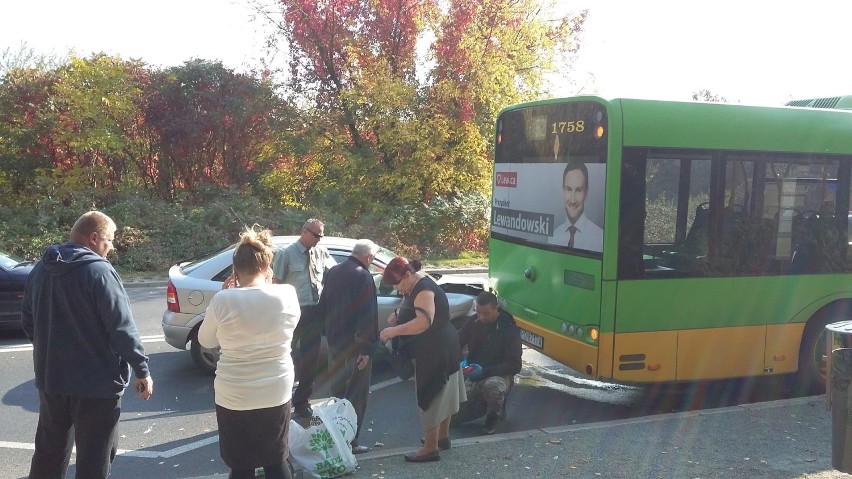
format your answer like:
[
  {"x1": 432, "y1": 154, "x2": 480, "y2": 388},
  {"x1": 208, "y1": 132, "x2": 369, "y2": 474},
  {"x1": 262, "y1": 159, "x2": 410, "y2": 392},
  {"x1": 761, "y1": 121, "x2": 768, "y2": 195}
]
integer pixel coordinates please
[{"x1": 198, "y1": 228, "x2": 299, "y2": 479}]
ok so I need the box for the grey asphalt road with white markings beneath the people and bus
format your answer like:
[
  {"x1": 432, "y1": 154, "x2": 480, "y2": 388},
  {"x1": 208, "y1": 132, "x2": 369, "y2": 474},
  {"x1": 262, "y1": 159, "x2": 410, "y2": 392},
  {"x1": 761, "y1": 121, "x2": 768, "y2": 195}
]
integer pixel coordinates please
[{"x1": 0, "y1": 288, "x2": 804, "y2": 479}]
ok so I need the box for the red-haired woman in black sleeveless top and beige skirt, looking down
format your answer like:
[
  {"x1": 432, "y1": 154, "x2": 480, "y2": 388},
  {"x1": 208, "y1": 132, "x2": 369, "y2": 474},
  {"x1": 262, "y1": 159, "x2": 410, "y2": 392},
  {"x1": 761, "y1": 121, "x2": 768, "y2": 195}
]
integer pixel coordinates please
[{"x1": 379, "y1": 256, "x2": 467, "y2": 462}]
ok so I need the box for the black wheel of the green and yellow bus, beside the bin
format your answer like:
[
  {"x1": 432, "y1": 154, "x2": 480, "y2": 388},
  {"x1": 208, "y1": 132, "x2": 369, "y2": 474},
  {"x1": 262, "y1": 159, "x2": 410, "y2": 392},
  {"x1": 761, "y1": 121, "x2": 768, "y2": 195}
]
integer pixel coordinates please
[{"x1": 791, "y1": 315, "x2": 829, "y2": 396}]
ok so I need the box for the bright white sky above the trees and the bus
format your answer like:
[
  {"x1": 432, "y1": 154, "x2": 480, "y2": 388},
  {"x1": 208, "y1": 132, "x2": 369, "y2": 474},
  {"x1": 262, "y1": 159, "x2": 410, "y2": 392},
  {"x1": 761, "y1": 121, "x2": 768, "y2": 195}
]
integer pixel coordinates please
[{"x1": 0, "y1": 0, "x2": 852, "y2": 105}]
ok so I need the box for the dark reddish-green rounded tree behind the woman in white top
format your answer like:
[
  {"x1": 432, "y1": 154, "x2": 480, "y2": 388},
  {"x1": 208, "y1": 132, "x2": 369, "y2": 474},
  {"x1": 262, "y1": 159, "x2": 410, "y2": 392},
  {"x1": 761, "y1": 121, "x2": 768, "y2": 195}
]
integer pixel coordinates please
[{"x1": 146, "y1": 60, "x2": 281, "y2": 198}]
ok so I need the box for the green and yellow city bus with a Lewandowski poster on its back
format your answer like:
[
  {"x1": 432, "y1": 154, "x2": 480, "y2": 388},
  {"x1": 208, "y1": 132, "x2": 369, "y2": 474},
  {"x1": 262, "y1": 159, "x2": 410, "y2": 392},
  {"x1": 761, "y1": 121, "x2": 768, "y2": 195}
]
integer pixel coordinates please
[{"x1": 489, "y1": 96, "x2": 852, "y2": 390}]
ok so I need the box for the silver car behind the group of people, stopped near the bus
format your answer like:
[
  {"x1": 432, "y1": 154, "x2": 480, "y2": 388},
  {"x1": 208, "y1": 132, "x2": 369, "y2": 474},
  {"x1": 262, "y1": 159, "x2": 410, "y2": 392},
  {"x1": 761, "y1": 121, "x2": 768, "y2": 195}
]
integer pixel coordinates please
[{"x1": 162, "y1": 236, "x2": 485, "y2": 373}]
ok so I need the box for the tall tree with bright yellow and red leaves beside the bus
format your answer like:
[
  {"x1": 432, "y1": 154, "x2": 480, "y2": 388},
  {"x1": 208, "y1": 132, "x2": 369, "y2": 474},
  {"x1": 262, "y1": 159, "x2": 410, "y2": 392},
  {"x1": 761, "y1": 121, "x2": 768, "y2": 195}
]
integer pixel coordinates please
[{"x1": 270, "y1": 0, "x2": 585, "y2": 218}]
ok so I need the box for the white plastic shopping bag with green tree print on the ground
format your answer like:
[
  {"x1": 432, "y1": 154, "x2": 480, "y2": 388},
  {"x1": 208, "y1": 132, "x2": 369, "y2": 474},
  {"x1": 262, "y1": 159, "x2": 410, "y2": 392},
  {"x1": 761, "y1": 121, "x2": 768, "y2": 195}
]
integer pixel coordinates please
[{"x1": 287, "y1": 398, "x2": 358, "y2": 479}]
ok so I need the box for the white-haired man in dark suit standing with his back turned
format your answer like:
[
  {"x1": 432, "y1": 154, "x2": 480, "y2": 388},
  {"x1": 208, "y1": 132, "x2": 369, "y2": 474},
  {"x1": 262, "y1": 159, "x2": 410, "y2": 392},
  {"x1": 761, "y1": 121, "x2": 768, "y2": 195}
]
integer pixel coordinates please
[{"x1": 320, "y1": 239, "x2": 379, "y2": 454}]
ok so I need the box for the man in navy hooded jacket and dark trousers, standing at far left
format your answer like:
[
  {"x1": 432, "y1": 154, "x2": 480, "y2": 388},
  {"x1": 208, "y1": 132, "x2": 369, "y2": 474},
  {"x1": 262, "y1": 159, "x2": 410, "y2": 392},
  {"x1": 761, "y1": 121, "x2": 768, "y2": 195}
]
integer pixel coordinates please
[{"x1": 21, "y1": 211, "x2": 154, "y2": 478}]
